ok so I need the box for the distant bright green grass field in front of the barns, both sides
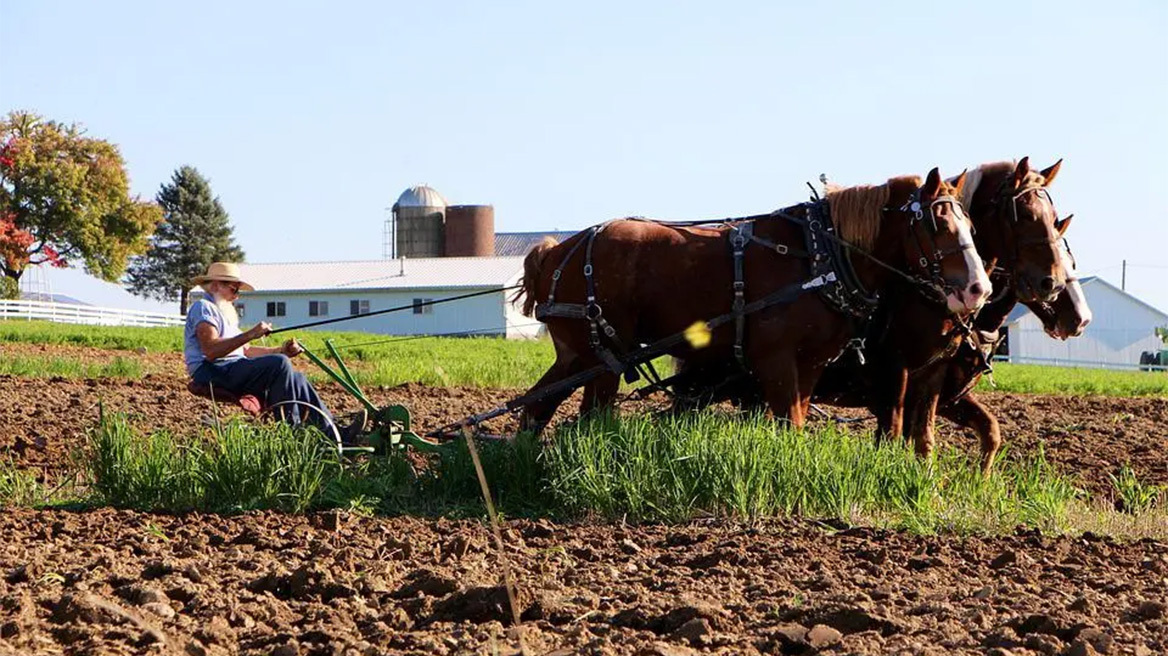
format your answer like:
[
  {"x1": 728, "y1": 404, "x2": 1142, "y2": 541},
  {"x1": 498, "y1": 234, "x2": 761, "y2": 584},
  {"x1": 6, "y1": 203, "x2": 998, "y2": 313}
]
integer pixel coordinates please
[{"x1": 0, "y1": 321, "x2": 1168, "y2": 396}]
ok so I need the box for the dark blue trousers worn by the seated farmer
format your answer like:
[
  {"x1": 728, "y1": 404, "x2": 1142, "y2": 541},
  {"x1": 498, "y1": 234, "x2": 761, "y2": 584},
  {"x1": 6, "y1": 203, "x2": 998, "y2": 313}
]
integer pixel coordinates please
[{"x1": 192, "y1": 354, "x2": 333, "y2": 435}]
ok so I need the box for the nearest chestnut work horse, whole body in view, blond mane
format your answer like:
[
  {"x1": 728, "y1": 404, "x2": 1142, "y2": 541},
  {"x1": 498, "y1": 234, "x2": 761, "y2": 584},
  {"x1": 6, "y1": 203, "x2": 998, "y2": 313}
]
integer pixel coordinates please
[{"x1": 521, "y1": 168, "x2": 992, "y2": 431}]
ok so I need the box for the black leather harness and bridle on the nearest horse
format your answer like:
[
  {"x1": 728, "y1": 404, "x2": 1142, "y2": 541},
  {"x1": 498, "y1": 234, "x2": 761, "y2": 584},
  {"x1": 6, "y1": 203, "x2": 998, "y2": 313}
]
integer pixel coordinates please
[{"x1": 535, "y1": 188, "x2": 975, "y2": 382}]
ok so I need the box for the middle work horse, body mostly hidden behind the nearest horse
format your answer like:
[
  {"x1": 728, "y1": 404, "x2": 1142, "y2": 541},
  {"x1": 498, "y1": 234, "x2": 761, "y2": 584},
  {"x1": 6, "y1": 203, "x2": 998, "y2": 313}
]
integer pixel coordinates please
[{"x1": 679, "y1": 158, "x2": 1085, "y2": 473}]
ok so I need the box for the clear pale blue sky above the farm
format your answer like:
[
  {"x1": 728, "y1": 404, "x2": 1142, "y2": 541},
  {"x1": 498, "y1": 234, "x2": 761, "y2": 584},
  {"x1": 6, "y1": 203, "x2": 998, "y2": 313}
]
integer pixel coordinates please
[{"x1": 0, "y1": 0, "x2": 1168, "y2": 309}]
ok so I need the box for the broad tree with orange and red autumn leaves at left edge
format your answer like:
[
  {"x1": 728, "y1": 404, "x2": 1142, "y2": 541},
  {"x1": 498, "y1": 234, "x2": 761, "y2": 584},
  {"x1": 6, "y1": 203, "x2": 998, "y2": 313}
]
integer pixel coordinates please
[{"x1": 0, "y1": 111, "x2": 161, "y2": 288}]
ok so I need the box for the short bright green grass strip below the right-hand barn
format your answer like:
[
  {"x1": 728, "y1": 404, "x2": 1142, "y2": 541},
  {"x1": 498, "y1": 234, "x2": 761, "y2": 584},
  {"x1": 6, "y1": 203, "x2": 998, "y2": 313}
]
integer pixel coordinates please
[{"x1": 978, "y1": 362, "x2": 1168, "y2": 397}]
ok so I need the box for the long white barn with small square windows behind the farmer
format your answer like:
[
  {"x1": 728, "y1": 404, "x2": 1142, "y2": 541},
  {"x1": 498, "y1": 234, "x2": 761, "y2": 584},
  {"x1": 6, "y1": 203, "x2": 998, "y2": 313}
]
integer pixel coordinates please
[{"x1": 216, "y1": 257, "x2": 540, "y2": 339}]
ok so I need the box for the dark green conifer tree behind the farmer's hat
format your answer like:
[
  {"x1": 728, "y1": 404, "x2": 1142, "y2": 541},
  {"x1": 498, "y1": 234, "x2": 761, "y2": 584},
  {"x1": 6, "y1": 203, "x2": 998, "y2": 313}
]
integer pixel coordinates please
[{"x1": 127, "y1": 166, "x2": 243, "y2": 314}]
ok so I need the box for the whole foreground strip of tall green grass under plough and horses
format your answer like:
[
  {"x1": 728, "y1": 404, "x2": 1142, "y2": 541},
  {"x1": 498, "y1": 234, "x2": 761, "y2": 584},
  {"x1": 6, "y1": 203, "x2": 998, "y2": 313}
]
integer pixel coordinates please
[{"x1": 0, "y1": 413, "x2": 1144, "y2": 539}]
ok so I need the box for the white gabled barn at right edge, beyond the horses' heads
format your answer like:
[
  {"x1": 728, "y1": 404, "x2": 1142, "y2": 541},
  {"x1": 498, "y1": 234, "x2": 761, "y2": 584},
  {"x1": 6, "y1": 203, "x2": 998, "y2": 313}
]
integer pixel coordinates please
[{"x1": 1000, "y1": 275, "x2": 1168, "y2": 369}]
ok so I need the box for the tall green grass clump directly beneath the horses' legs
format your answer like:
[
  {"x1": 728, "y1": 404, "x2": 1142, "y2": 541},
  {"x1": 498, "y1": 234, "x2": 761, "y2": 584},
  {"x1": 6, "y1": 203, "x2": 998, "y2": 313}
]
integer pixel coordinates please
[{"x1": 544, "y1": 413, "x2": 1079, "y2": 532}]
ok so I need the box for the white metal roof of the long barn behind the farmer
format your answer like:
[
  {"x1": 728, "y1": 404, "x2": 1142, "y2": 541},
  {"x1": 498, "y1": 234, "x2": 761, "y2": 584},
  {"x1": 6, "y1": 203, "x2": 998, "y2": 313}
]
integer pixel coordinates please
[{"x1": 230, "y1": 257, "x2": 523, "y2": 292}]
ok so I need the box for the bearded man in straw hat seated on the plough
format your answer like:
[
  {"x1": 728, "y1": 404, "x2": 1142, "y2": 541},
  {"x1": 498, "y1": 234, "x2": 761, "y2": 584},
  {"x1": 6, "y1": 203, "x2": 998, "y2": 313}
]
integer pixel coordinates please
[{"x1": 182, "y1": 261, "x2": 364, "y2": 442}]
